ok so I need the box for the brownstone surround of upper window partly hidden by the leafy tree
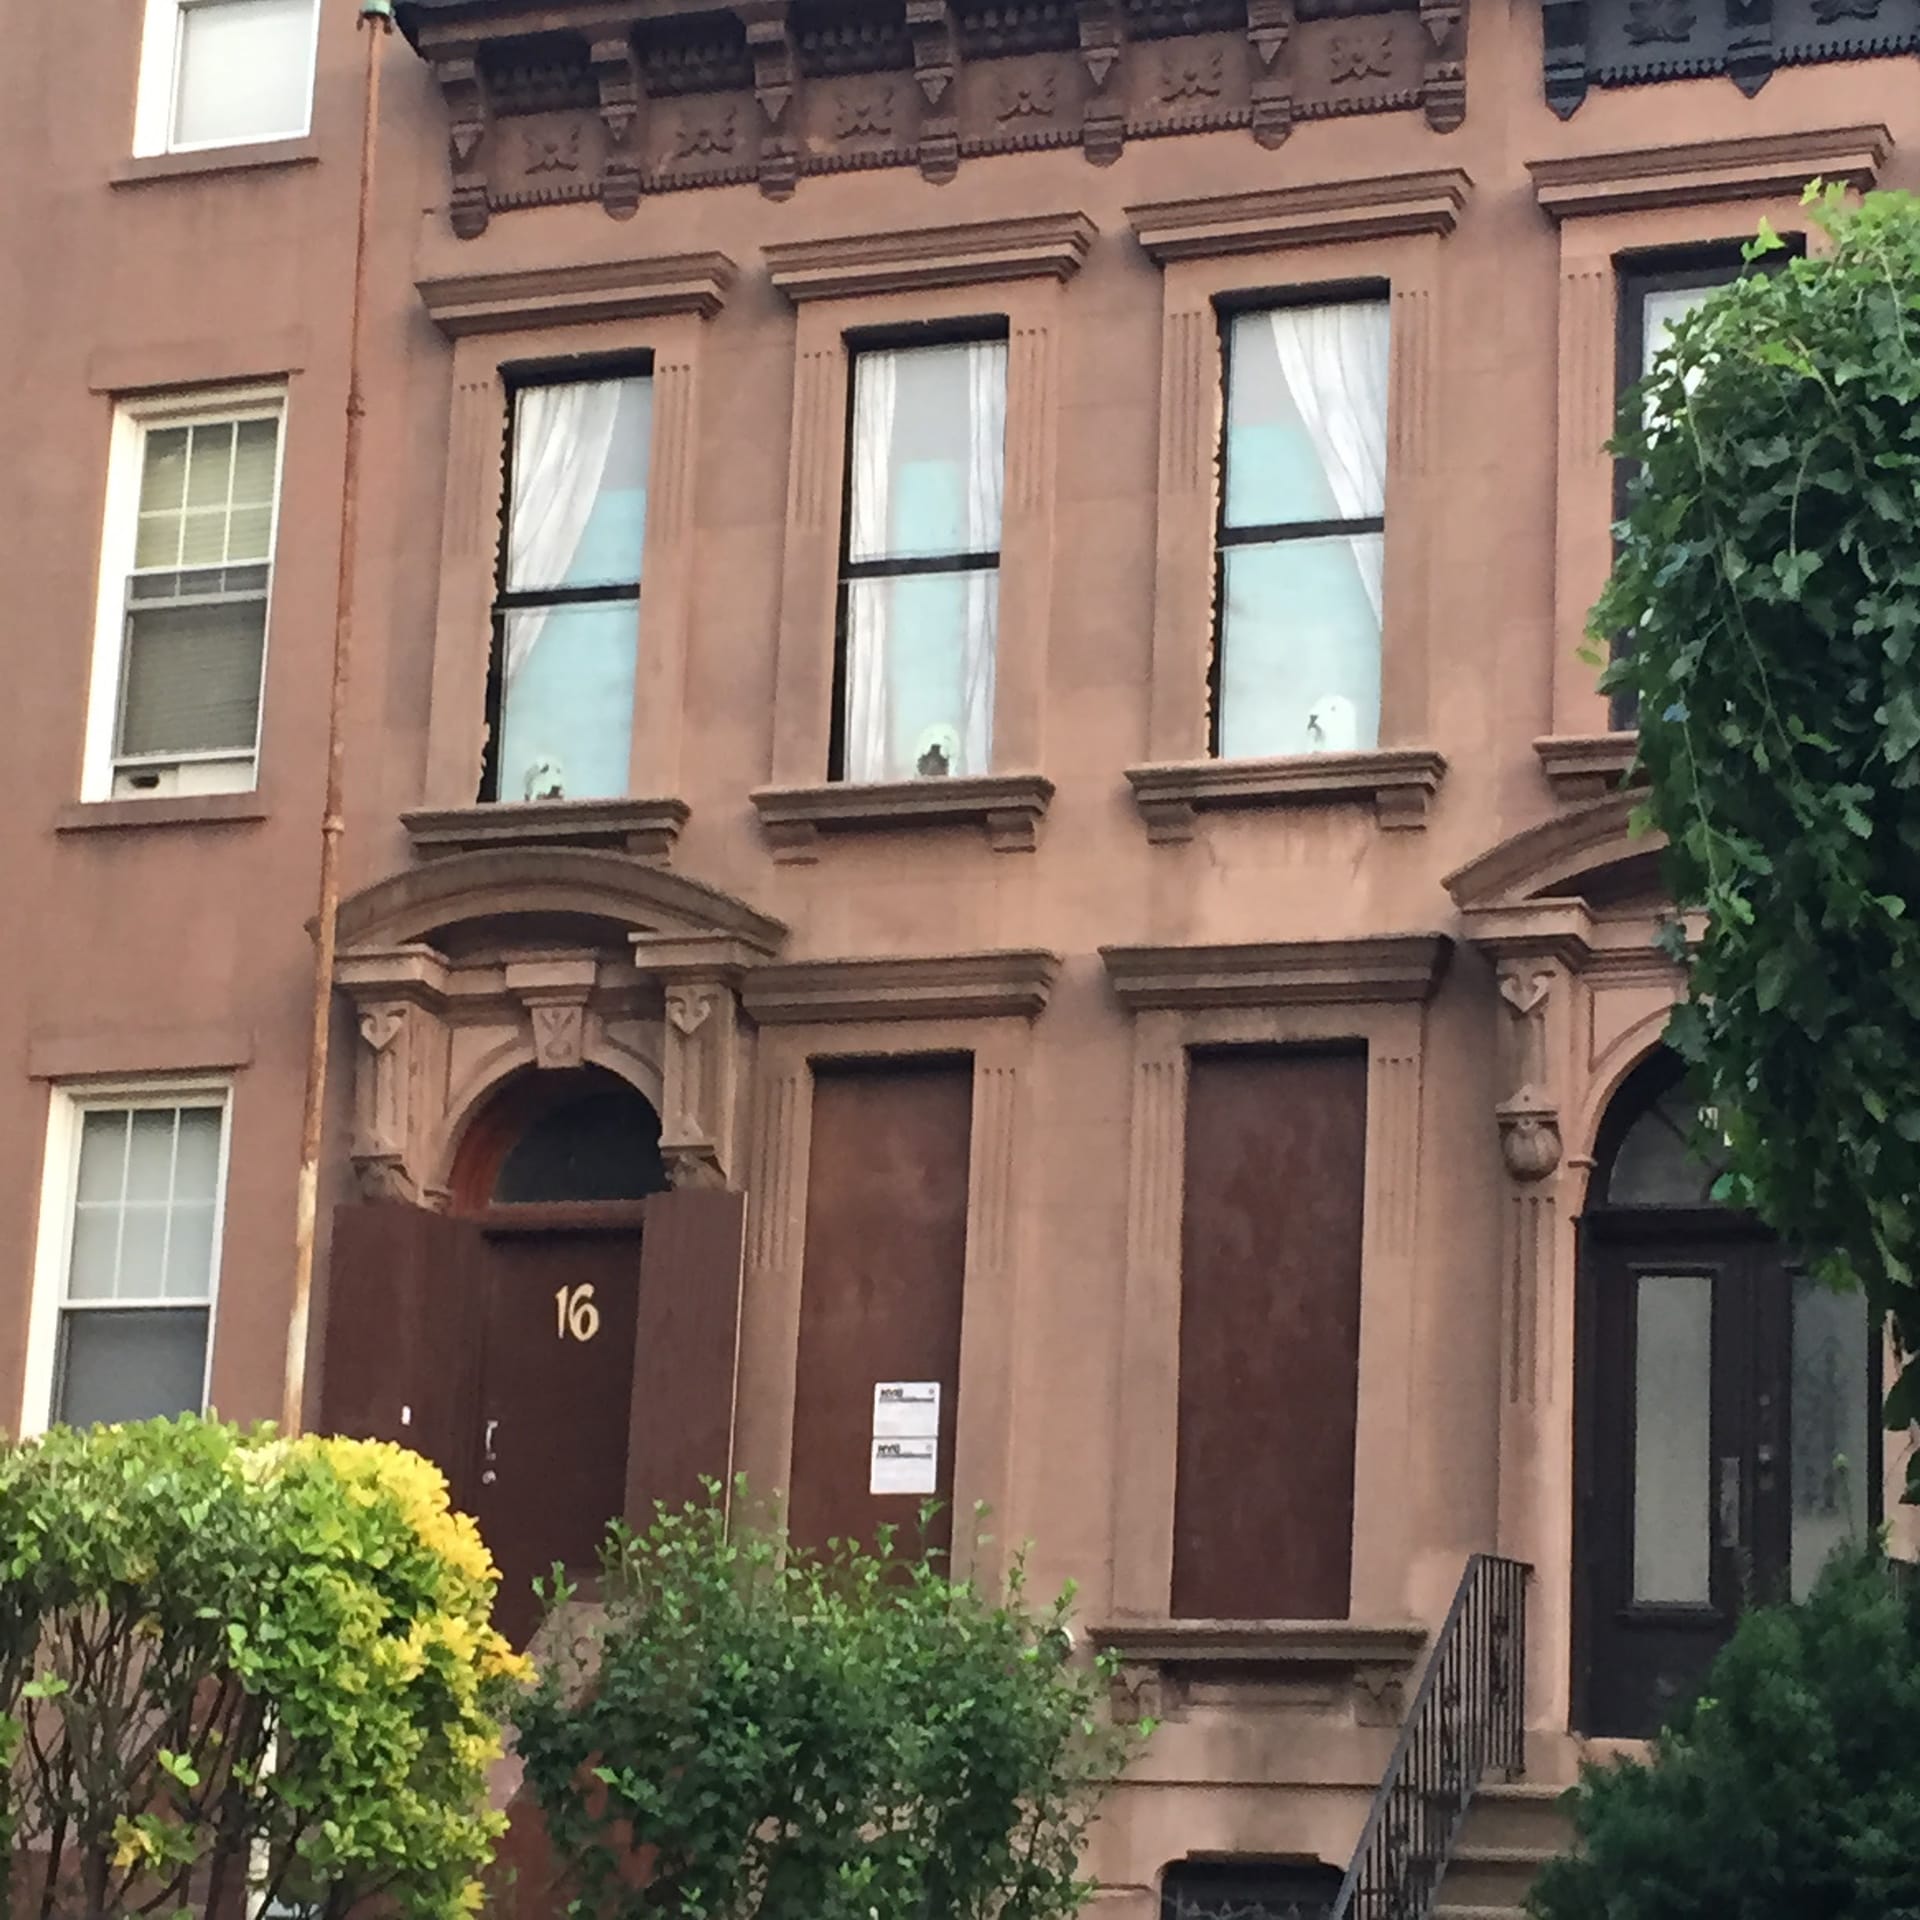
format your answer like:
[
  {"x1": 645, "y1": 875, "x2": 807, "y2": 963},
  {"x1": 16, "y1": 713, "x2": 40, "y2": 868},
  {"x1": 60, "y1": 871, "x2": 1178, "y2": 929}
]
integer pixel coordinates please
[{"x1": 1528, "y1": 127, "x2": 1891, "y2": 748}]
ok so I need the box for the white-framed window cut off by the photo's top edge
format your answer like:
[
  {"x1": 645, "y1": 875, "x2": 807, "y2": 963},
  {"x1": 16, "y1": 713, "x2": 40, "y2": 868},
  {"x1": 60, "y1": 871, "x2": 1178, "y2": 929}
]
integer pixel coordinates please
[{"x1": 132, "y1": 0, "x2": 321, "y2": 154}]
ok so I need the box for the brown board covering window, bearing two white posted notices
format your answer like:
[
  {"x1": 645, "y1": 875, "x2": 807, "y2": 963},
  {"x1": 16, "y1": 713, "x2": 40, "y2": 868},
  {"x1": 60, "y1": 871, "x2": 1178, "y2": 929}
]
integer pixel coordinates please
[{"x1": 789, "y1": 1060, "x2": 973, "y2": 1549}]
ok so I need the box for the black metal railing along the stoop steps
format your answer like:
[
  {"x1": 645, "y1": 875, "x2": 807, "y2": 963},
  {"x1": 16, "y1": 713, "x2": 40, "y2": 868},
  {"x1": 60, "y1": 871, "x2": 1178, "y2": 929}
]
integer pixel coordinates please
[{"x1": 1329, "y1": 1553, "x2": 1532, "y2": 1920}]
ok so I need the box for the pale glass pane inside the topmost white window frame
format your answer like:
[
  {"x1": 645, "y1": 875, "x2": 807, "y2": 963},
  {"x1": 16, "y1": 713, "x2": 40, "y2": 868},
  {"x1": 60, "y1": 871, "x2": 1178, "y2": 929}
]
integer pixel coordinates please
[{"x1": 173, "y1": 0, "x2": 317, "y2": 146}]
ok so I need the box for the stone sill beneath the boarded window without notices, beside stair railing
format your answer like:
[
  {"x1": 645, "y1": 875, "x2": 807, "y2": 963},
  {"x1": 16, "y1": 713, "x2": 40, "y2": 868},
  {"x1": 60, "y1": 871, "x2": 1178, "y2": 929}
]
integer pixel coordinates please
[{"x1": 1092, "y1": 1620, "x2": 1428, "y2": 1726}]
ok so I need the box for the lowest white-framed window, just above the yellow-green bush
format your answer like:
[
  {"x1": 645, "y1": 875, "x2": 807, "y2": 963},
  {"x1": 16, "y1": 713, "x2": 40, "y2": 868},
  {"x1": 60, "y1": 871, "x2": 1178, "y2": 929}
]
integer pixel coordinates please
[{"x1": 19, "y1": 1081, "x2": 230, "y2": 1434}]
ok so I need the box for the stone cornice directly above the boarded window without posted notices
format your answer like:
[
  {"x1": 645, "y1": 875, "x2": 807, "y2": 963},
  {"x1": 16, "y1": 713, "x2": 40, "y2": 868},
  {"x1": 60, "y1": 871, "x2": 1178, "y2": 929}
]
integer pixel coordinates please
[{"x1": 1100, "y1": 933, "x2": 1453, "y2": 1014}]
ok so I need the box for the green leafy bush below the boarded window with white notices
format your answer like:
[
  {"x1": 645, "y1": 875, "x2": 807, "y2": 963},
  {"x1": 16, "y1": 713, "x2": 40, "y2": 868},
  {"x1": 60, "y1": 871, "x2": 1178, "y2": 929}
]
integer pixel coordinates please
[{"x1": 516, "y1": 1490, "x2": 1129, "y2": 1920}]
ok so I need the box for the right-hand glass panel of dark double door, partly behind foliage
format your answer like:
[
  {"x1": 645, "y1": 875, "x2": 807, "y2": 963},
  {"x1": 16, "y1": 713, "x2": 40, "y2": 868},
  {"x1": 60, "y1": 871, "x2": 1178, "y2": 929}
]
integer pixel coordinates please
[{"x1": 1793, "y1": 1275, "x2": 1870, "y2": 1599}]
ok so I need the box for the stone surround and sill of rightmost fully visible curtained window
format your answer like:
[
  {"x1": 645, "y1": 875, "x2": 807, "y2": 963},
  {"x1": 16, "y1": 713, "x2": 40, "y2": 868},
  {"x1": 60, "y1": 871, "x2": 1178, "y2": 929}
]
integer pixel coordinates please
[{"x1": 1127, "y1": 169, "x2": 1473, "y2": 845}]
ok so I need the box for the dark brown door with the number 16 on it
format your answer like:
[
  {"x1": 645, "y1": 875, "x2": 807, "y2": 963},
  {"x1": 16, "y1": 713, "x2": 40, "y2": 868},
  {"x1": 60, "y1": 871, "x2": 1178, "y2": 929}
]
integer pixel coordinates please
[{"x1": 472, "y1": 1223, "x2": 639, "y2": 1642}]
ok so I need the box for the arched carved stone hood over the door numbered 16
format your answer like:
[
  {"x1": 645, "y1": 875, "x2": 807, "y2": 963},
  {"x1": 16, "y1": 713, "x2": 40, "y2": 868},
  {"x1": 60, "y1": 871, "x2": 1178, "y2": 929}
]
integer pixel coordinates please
[{"x1": 334, "y1": 847, "x2": 787, "y2": 1206}]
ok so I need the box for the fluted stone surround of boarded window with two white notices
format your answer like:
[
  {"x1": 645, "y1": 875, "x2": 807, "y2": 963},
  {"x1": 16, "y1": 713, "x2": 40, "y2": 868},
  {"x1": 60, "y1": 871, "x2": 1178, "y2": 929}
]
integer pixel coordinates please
[{"x1": 735, "y1": 950, "x2": 1058, "y2": 1576}]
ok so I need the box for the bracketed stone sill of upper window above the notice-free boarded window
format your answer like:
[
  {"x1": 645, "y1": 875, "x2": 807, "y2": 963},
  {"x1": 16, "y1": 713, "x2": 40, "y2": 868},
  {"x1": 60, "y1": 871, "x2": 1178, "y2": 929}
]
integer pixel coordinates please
[{"x1": 1127, "y1": 747, "x2": 1446, "y2": 847}]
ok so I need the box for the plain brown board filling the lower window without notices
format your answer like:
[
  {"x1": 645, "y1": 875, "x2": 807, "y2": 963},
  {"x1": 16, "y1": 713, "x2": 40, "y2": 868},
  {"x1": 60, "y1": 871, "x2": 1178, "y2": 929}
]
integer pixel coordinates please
[{"x1": 1173, "y1": 1048, "x2": 1367, "y2": 1619}]
